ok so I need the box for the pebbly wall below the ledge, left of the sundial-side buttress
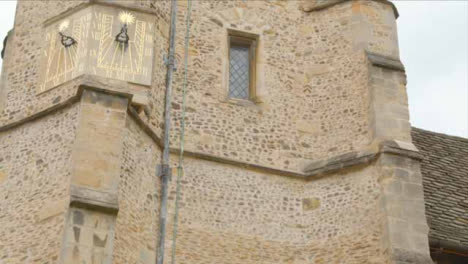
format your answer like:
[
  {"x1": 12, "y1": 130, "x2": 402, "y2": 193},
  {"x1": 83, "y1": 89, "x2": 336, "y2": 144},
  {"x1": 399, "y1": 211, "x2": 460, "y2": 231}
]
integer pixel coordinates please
[{"x1": 0, "y1": 105, "x2": 79, "y2": 264}]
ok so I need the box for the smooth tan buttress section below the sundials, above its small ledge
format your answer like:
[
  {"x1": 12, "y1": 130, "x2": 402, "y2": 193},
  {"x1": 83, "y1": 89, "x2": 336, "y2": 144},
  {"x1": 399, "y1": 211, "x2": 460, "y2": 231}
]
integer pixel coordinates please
[{"x1": 72, "y1": 90, "x2": 128, "y2": 191}]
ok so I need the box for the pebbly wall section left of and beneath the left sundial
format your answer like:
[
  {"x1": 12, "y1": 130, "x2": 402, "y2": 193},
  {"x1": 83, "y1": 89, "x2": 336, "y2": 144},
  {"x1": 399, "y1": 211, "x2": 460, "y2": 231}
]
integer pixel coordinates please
[{"x1": 0, "y1": 1, "x2": 86, "y2": 122}]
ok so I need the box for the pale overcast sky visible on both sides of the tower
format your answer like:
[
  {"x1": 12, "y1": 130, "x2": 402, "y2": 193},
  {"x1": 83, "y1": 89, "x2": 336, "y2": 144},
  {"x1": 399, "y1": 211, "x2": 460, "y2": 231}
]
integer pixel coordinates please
[{"x1": 0, "y1": 0, "x2": 468, "y2": 137}]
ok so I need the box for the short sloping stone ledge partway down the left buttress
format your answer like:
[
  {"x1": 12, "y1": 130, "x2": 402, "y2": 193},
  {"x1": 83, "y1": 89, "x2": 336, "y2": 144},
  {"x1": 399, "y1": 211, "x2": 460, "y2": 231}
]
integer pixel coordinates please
[{"x1": 70, "y1": 185, "x2": 119, "y2": 214}]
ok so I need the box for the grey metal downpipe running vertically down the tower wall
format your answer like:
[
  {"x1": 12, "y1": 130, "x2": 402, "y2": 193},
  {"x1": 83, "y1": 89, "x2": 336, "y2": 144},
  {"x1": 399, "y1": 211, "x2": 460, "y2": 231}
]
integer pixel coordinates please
[{"x1": 156, "y1": 0, "x2": 177, "y2": 264}]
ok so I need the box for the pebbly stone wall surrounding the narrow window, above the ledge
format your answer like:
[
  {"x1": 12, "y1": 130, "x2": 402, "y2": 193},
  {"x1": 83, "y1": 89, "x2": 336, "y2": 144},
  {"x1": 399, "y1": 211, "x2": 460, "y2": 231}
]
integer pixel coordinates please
[{"x1": 168, "y1": 1, "x2": 398, "y2": 171}]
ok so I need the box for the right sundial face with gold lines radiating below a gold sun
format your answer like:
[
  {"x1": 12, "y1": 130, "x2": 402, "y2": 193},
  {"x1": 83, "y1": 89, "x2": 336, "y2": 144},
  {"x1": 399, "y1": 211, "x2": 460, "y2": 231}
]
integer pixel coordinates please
[{"x1": 90, "y1": 6, "x2": 154, "y2": 85}]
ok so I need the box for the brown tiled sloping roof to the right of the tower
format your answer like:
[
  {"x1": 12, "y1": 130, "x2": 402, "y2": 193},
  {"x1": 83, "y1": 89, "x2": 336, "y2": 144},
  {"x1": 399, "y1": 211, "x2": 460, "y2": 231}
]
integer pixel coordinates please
[{"x1": 412, "y1": 128, "x2": 468, "y2": 249}]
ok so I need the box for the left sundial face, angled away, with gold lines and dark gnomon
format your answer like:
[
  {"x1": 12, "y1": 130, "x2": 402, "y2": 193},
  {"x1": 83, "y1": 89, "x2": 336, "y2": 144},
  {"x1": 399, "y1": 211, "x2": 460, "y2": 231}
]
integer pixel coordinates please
[{"x1": 39, "y1": 8, "x2": 91, "y2": 92}]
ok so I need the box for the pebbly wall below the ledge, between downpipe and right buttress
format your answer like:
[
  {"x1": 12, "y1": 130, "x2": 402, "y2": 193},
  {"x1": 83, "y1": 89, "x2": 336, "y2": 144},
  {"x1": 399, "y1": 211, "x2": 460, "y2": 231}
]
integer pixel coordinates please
[{"x1": 166, "y1": 158, "x2": 388, "y2": 264}]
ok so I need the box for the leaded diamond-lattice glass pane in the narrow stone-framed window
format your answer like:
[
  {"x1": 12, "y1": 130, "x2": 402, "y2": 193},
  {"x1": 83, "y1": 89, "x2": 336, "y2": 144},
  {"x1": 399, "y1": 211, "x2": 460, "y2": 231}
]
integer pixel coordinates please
[{"x1": 229, "y1": 45, "x2": 250, "y2": 99}]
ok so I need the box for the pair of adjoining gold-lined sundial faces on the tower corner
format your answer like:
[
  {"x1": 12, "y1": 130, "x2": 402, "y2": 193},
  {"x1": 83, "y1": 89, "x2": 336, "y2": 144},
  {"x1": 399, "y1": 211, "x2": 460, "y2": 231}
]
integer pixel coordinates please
[{"x1": 39, "y1": 5, "x2": 154, "y2": 92}]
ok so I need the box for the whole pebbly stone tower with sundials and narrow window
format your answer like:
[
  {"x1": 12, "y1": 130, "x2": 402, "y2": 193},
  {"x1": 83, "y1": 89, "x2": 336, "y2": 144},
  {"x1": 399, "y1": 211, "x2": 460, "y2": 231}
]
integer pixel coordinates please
[{"x1": 0, "y1": 0, "x2": 431, "y2": 264}]
